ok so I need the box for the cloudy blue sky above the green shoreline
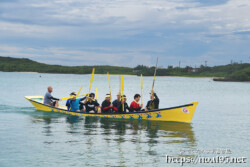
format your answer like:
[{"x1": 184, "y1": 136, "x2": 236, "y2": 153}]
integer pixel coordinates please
[{"x1": 0, "y1": 0, "x2": 250, "y2": 67}]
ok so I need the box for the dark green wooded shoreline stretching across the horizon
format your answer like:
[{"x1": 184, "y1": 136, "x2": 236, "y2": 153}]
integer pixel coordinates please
[{"x1": 0, "y1": 57, "x2": 250, "y2": 81}]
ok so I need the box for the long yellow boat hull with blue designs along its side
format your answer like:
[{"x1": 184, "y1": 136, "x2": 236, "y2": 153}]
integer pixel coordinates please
[{"x1": 25, "y1": 96, "x2": 198, "y2": 123}]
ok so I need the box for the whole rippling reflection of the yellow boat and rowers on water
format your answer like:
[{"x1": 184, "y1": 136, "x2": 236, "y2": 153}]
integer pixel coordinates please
[{"x1": 29, "y1": 113, "x2": 197, "y2": 162}]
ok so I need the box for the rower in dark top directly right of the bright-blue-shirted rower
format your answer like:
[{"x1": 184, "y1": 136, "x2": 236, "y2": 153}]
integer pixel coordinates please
[{"x1": 83, "y1": 93, "x2": 100, "y2": 113}]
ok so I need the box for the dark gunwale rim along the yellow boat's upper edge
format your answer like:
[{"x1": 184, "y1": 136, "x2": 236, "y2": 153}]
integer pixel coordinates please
[{"x1": 26, "y1": 98, "x2": 194, "y2": 115}]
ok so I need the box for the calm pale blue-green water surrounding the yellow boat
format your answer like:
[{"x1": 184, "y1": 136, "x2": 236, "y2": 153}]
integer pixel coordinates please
[{"x1": 0, "y1": 72, "x2": 250, "y2": 167}]
